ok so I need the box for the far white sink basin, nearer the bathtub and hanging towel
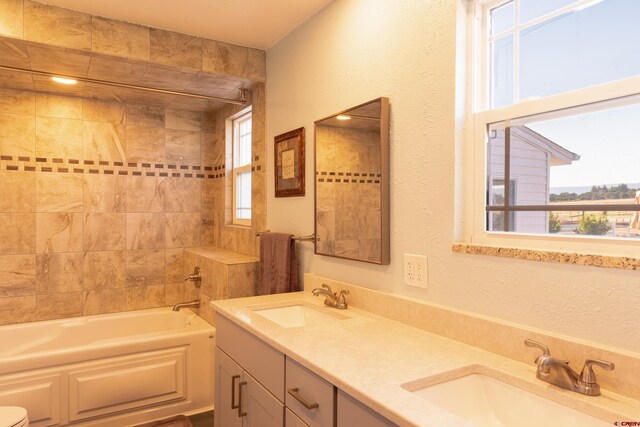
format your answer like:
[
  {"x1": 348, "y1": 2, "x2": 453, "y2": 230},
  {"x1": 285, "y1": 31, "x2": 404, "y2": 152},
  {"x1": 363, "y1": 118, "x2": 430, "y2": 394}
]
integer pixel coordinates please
[{"x1": 249, "y1": 301, "x2": 348, "y2": 328}]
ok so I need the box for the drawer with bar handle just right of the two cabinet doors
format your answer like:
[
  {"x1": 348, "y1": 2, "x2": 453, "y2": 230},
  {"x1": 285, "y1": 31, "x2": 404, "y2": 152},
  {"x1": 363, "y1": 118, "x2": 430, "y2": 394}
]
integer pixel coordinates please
[{"x1": 285, "y1": 358, "x2": 335, "y2": 427}]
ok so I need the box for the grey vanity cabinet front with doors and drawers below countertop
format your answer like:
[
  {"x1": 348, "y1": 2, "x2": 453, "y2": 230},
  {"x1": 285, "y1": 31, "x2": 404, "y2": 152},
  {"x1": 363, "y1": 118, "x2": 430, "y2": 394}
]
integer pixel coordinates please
[{"x1": 214, "y1": 316, "x2": 395, "y2": 427}]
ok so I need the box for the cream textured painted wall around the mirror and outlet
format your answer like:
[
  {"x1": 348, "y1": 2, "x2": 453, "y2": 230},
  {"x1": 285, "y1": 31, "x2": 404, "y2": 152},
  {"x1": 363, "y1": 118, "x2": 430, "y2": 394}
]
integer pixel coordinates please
[{"x1": 266, "y1": 0, "x2": 640, "y2": 351}]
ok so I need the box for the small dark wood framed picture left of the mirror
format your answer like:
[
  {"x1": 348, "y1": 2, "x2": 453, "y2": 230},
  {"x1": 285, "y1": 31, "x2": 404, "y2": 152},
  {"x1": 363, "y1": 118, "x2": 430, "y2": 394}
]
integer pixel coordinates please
[{"x1": 274, "y1": 127, "x2": 305, "y2": 197}]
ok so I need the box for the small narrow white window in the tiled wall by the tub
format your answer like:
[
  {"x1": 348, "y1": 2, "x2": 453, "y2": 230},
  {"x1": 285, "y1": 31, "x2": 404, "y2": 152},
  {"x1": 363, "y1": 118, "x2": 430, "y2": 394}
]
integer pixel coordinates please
[{"x1": 230, "y1": 109, "x2": 251, "y2": 225}]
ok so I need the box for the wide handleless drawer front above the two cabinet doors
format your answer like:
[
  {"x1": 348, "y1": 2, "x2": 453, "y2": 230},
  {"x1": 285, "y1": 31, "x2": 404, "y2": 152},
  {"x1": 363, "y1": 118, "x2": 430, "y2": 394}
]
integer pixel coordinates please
[{"x1": 216, "y1": 315, "x2": 284, "y2": 402}]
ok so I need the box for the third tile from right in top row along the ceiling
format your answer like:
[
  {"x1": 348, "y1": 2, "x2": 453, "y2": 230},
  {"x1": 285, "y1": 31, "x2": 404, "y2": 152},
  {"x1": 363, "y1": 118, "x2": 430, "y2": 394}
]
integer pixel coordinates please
[{"x1": 150, "y1": 28, "x2": 202, "y2": 70}]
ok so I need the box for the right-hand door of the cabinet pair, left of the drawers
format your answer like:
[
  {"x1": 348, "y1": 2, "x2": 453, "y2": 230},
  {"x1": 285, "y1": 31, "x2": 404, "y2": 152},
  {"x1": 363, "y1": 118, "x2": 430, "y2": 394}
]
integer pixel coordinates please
[{"x1": 244, "y1": 372, "x2": 284, "y2": 427}]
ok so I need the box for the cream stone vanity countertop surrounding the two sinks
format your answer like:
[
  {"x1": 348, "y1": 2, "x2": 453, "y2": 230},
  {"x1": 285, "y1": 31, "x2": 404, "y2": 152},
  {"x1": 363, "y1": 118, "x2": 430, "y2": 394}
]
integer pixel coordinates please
[{"x1": 211, "y1": 292, "x2": 640, "y2": 426}]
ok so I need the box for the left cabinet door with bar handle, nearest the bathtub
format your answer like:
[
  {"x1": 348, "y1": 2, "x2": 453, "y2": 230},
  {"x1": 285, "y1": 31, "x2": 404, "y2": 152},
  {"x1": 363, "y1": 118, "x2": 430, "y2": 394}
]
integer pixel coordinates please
[{"x1": 213, "y1": 348, "x2": 243, "y2": 427}]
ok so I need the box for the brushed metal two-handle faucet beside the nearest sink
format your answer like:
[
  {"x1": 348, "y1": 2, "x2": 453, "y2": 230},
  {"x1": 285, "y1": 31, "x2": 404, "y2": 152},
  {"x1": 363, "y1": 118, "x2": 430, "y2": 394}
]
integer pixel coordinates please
[{"x1": 524, "y1": 339, "x2": 615, "y2": 396}]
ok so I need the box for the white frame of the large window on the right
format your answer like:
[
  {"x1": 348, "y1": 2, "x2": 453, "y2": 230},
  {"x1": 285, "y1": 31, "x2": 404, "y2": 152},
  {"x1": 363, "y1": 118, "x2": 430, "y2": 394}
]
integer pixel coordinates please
[{"x1": 465, "y1": 0, "x2": 640, "y2": 257}]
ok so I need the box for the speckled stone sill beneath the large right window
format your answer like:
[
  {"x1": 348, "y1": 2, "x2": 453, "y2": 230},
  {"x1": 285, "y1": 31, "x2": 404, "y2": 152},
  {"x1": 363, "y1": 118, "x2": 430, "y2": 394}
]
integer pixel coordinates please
[{"x1": 451, "y1": 243, "x2": 640, "y2": 271}]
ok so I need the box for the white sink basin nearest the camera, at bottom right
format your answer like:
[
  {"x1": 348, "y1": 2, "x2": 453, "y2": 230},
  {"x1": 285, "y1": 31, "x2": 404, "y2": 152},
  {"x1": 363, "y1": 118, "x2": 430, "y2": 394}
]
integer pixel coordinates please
[{"x1": 403, "y1": 374, "x2": 611, "y2": 427}]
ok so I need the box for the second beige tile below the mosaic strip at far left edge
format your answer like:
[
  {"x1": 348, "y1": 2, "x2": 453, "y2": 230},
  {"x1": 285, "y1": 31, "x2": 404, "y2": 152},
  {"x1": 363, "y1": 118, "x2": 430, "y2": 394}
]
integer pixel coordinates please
[{"x1": 0, "y1": 213, "x2": 36, "y2": 255}]
